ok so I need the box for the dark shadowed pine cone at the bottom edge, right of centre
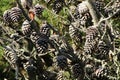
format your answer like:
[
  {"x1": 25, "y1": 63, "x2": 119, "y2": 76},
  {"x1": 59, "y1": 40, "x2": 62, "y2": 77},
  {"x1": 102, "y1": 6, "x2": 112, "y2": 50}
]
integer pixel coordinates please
[{"x1": 72, "y1": 63, "x2": 84, "y2": 80}]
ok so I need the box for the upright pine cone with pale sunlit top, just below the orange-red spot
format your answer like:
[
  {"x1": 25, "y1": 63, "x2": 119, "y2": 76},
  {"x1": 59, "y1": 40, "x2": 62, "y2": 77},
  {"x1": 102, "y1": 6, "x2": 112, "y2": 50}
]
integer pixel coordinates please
[{"x1": 22, "y1": 20, "x2": 32, "y2": 35}]
